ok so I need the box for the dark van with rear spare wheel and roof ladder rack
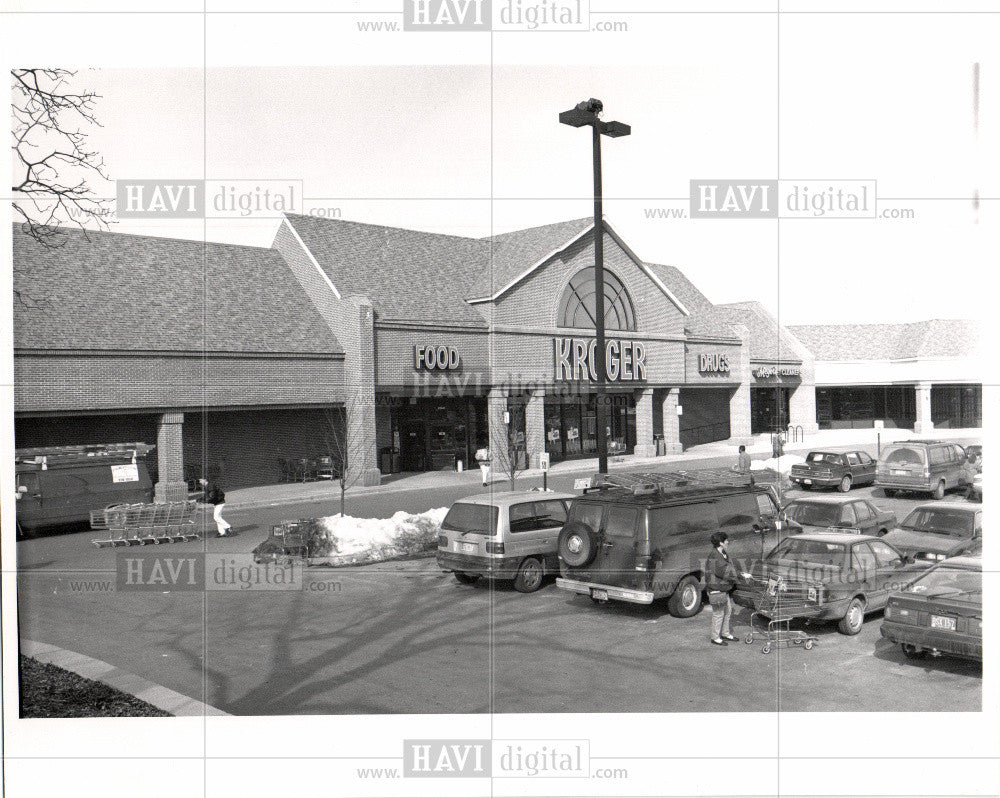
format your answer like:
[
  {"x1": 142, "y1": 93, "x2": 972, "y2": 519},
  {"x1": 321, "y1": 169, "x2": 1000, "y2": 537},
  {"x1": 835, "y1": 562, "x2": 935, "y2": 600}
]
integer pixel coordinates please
[{"x1": 556, "y1": 472, "x2": 782, "y2": 618}]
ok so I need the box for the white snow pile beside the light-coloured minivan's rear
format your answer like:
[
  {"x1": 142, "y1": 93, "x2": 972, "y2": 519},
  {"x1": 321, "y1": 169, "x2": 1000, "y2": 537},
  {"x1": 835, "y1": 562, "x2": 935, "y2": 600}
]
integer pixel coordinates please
[{"x1": 310, "y1": 507, "x2": 448, "y2": 565}]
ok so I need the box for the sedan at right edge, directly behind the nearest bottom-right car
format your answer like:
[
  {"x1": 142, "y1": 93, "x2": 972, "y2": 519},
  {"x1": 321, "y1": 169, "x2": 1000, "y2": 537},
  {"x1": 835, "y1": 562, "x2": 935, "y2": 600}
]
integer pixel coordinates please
[{"x1": 885, "y1": 502, "x2": 983, "y2": 562}]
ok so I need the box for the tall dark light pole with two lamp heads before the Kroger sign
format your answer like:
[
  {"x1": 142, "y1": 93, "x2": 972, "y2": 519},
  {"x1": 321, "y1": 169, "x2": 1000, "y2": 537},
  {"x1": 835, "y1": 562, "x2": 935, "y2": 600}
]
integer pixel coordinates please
[{"x1": 559, "y1": 97, "x2": 632, "y2": 474}]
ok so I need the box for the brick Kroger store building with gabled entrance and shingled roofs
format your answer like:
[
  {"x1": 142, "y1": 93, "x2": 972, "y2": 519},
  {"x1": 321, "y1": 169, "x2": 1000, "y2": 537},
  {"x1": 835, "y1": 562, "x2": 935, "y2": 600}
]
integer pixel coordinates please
[{"x1": 14, "y1": 215, "x2": 981, "y2": 497}]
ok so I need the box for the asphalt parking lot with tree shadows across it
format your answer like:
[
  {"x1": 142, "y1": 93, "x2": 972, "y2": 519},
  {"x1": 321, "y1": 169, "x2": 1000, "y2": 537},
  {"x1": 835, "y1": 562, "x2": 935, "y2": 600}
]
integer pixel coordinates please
[{"x1": 18, "y1": 478, "x2": 982, "y2": 715}]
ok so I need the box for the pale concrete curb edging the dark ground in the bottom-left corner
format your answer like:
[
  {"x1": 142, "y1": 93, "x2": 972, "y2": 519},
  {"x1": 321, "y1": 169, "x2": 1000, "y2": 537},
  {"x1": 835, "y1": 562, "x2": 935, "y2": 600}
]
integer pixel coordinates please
[{"x1": 21, "y1": 640, "x2": 229, "y2": 717}]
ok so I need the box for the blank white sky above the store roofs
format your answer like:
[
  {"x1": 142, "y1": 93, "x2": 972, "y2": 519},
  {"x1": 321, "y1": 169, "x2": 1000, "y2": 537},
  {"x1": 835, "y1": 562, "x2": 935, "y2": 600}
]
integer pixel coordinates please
[{"x1": 7, "y1": 10, "x2": 1000, "y2": 324}]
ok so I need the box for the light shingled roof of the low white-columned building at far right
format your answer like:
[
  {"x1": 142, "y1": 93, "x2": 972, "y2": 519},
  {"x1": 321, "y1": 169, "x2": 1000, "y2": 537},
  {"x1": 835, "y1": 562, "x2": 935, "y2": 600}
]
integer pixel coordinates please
[{"x1": 789, "y1": 319, "x2": 982, "y2": 360}]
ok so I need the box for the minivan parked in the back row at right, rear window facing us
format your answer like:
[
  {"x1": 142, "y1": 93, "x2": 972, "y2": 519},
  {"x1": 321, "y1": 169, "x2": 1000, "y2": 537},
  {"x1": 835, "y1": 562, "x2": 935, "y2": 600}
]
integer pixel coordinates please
[{"x1": 875, "y1": 441, "x2": 973, "y2": 499}]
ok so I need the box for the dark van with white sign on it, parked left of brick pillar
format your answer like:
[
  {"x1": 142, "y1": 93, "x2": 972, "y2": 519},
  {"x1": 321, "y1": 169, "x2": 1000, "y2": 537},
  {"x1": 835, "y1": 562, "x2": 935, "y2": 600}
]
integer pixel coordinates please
[{"x1": 14, "y1": 444, "x2": 153, "y2": 532}]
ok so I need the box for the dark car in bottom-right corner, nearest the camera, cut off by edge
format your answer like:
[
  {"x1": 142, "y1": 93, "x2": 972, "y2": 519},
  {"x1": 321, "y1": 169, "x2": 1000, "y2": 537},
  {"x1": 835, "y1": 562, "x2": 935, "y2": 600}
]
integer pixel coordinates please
[{"x1": 882, "y1": 556, "x2": 983, "y2": 661}]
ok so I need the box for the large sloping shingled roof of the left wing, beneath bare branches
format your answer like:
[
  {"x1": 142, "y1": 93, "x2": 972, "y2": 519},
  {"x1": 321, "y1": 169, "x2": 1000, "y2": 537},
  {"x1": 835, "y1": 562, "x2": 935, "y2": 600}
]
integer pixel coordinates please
[{"x1": 13, "y1": 225, "x2": 343, "y2": 354}]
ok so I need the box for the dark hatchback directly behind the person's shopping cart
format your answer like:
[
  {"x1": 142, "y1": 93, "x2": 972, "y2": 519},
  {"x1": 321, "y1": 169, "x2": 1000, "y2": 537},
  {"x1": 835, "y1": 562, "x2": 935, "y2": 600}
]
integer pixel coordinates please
[{"x1": 733, "y1": 532, "x2": 926, "y2": 635}]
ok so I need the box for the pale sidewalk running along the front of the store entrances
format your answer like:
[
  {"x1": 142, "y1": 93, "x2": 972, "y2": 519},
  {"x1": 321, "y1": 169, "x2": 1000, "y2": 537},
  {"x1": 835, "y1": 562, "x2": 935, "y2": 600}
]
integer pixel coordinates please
[{"x1": 226, "y1": 429, "x2": 983, "y2": 510}]
